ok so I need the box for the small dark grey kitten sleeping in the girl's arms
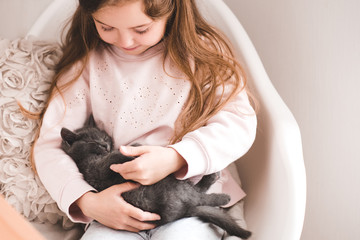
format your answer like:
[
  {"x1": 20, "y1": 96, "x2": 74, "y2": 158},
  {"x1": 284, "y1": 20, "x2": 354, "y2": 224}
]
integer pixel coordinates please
[{"x1": 61, "y1": 116, "x2": 251, "y2": 239}]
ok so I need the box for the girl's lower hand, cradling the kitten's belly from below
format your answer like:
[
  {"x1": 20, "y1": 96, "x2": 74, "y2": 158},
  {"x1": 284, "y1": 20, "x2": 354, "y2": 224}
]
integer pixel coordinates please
[{"x1": 76, "y1": 183, "x2": 160, "y2": 232}]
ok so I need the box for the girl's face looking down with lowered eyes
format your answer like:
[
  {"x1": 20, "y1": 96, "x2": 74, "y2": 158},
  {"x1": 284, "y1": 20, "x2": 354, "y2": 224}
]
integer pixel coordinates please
[{"x1": 92, "y1": 0, "x2": 167, "y2": 55}]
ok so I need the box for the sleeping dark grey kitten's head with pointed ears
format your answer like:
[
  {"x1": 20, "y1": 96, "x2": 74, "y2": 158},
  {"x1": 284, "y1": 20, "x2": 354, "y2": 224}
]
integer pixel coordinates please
[{"x1": 61, "y1": 115, "x2": 113, "y2": 160}]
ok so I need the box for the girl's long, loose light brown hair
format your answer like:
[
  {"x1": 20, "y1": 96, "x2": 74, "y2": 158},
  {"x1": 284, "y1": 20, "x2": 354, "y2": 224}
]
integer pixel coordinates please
[{"x1": 28, "y1": 0, "x2": 250, "y2": 169}]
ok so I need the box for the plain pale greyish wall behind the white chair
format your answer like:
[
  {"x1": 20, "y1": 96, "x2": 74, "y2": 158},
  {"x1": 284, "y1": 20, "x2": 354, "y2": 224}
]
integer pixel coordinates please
[{"x1": 0, "y1": 0, "x2": 360, "y2": 240}]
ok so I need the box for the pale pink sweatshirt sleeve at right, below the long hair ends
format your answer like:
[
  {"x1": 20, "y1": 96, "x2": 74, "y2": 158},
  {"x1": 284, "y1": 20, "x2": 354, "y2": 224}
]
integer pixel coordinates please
[{"x1": 170, "y1": 91, "x2": 257, "y2": 179}]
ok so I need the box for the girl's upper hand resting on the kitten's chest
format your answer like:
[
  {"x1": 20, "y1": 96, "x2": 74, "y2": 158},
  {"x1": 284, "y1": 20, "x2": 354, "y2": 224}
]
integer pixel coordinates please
[{"x1": 110, "y1": 146, "x2": 186, "y2": 185}]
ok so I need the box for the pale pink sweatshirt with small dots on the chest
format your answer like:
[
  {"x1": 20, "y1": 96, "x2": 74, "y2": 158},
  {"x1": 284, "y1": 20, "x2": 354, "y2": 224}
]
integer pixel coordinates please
[{"x1": 34, "y1": 43, "x2": 256, "y2": 223}]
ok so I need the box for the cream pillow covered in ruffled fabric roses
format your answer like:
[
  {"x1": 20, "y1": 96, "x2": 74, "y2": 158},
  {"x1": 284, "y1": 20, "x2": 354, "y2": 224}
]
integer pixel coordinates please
[{"x1": 0, "y1": 38, "x2": 73, "y2": 228}]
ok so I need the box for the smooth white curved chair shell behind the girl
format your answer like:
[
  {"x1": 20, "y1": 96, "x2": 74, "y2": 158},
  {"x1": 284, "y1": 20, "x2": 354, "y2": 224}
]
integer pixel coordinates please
[{"x1": 28, "y1": 0, "x2": 306, "y2": 240}]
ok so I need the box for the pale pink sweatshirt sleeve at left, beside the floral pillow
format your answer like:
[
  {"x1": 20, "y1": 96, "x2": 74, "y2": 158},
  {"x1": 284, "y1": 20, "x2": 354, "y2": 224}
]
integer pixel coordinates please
[{"x1": 34, "y1": 63, "x2": 94, "y2": 223}]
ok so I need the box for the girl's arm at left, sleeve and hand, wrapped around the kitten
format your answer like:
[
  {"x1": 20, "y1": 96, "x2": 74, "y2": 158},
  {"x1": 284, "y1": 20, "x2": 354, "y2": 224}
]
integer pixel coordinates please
[{"x1": 34, "y1": 64, "x2": 159, "y2": 227}]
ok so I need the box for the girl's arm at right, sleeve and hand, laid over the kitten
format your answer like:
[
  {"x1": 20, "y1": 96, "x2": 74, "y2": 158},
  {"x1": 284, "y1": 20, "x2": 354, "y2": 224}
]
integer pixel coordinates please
[{"x1": 111, "y1": 89, "x2": 257, "y2": 185}]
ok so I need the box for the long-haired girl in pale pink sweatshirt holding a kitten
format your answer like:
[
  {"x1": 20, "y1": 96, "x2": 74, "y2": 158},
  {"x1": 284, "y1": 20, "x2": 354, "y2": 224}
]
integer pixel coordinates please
[{"x1": 33, "y1": 0, "x2": 256, "y2": 240}]
